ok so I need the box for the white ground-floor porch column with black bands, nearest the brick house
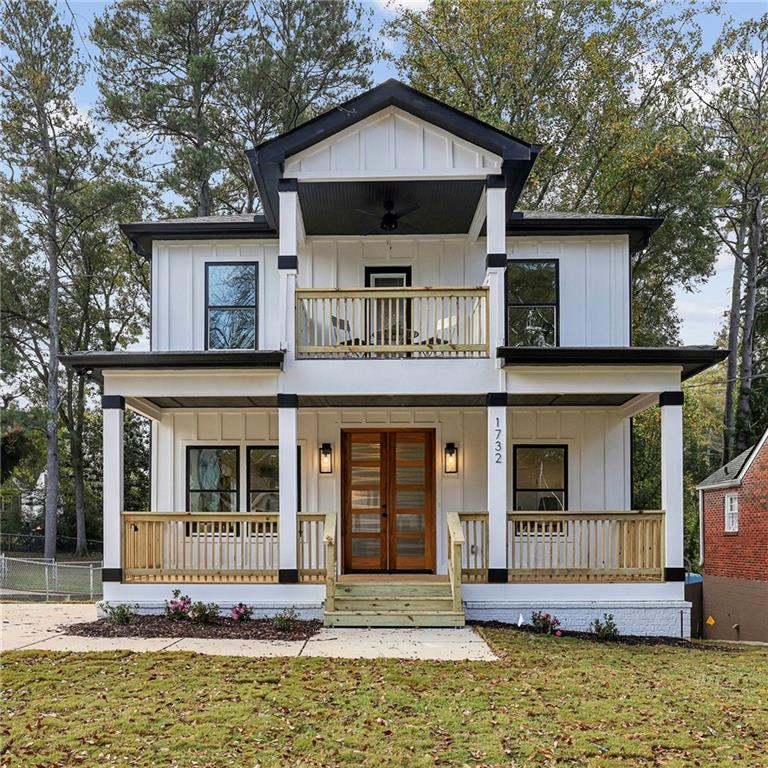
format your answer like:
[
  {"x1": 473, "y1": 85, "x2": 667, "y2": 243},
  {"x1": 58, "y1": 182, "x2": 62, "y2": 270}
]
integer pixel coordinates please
[{"x1": 659, "y1": 391, "x2": 685, "y2": 581}]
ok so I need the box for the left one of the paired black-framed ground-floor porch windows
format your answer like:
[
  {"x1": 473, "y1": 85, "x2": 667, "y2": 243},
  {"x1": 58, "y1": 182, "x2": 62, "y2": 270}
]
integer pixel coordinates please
[{"x1": 187, "y1": 445, "x2": 240, "y2": 512}]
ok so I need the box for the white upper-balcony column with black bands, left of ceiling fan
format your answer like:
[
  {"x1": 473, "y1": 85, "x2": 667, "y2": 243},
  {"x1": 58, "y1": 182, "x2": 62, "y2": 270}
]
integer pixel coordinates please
[{"x1": 277, "y1": 179, "x2": 302, "y2": 358}]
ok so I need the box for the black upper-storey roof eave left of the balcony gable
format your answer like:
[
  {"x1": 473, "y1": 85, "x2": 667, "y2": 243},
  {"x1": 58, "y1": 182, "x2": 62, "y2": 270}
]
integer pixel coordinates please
[{"x1": 120, "y1": 214, "x2": 277, "y2": 259}]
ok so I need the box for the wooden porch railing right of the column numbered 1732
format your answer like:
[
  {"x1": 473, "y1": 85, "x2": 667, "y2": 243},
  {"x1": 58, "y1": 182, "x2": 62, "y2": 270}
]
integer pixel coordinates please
[{"x1": 507, "y1": 511, "x2": 664, "y2": 582}]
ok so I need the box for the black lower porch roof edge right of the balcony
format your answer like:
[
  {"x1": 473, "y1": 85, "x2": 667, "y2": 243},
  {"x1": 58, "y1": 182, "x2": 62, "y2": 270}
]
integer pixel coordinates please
[{"x1": 498, "y1": 347, "x2": 728, "y2": 380}]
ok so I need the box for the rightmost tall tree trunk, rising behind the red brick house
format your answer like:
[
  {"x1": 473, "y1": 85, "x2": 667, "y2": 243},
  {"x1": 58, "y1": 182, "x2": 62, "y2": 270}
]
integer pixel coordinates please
[{"x1": 736, "y1": 191, "x2": 763, "y2": 453}]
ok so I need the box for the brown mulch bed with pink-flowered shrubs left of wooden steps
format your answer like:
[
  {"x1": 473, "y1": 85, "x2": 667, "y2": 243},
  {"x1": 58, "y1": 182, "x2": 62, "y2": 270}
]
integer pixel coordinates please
[{"x1": 64, "y1": 616, "x2": 322, "y2": 640}]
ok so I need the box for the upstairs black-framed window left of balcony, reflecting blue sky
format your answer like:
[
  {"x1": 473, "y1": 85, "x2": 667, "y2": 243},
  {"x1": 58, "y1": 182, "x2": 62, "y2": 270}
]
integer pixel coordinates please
[{"x1": 205, "y1": 261, "x2": 259, "y2": 349}]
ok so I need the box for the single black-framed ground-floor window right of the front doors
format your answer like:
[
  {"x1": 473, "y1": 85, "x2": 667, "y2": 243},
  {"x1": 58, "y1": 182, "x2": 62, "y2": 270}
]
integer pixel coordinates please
[{"x1": 513, "y1": 445, "x2": 568, "y2": 512}]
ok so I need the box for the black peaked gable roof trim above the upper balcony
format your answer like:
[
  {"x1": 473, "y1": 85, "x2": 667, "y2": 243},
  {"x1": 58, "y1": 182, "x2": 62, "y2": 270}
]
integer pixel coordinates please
[{"x1": 246, "y1": 79, "x2": 541, "y2": 229}]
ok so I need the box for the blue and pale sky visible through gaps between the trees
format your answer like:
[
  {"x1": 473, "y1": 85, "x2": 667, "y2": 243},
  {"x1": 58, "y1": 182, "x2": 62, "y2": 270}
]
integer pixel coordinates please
[{"x1": 61, "y1": 0, "x2": 768, "y2": 344}]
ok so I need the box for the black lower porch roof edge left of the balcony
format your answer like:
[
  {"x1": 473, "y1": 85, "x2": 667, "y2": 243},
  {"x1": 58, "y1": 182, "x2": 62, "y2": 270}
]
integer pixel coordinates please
[{"x1": 59, "y1": 349, "x2": 285, "y2": 380}]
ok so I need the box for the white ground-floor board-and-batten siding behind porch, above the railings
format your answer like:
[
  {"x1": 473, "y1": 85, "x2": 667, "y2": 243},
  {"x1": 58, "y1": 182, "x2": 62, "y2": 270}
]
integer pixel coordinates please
[{"x1": 152, "y1": 408, "x2": 630, "y2": 566}]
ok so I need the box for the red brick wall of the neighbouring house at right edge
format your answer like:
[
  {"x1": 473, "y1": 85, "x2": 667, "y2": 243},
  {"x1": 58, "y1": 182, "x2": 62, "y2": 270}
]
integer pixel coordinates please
[{"x1": 703, "y1": 441, "x2": 768, "y2": 581}]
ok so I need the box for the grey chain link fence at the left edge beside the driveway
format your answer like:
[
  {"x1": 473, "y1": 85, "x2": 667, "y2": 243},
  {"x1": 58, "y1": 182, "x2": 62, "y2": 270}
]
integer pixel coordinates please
[{"x1": 0, "y1": 555, "x2": 102, "y2": 601}]
